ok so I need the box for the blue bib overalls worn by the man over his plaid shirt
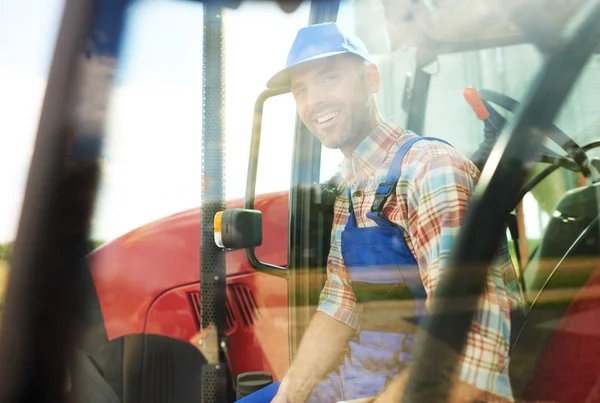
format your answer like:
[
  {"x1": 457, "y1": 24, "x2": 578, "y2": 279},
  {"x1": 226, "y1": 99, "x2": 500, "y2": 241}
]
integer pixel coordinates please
[{"x1": 240, "y1": 137, "x2": 444, "y2": 403}]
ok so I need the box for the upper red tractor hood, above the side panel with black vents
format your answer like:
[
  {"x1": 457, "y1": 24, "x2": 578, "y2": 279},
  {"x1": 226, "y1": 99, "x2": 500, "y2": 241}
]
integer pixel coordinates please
[{"x1": 88, "y1": 192, "x2": 288, "y2": 340}]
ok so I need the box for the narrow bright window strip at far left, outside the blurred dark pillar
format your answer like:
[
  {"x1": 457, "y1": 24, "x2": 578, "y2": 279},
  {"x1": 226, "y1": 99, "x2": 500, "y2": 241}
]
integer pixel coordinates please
[{"x1": 0, "y1": 0, "x2": 64, "y2": 323}]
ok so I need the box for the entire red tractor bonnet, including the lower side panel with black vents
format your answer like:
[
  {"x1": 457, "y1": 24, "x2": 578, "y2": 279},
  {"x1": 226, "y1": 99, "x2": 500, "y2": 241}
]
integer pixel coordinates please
[{"x1": 89, "y1": 192, "x2": 289, "y2": 379}]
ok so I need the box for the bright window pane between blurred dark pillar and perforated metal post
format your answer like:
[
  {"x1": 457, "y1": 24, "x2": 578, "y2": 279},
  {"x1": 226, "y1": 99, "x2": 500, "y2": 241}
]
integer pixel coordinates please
[{"x1": 93, "y1": 1, "x2": 203, "y2": 241}]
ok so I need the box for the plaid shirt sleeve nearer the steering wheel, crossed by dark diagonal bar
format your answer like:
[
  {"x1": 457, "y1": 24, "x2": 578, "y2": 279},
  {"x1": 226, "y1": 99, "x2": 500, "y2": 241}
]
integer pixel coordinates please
[{"x1": 399, "y1": 143, "x2": 512, "y2": 401}]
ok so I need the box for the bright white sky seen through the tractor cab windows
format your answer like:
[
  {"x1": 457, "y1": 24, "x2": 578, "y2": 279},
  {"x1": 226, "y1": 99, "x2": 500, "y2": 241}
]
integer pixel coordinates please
[{"x1": 0, "y1": 0, "x2": 352, "y2": 242}]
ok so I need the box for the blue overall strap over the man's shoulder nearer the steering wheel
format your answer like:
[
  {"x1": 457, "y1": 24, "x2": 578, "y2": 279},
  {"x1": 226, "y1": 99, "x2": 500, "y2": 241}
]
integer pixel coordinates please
[{"x1": 367, "y1": 137, "x2": 451, "y2": 227}]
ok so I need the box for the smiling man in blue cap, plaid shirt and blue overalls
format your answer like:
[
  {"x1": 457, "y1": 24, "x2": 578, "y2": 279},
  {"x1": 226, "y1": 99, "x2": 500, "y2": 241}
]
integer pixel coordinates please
[{"x1": 237, "y1": 23, "x2": 520, "y2": 403}]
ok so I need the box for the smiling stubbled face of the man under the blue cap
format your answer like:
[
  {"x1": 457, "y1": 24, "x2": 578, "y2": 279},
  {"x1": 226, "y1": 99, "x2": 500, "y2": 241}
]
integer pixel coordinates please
[{"x1": 291, "y1": 56, "x2": 373, "y2": 153}]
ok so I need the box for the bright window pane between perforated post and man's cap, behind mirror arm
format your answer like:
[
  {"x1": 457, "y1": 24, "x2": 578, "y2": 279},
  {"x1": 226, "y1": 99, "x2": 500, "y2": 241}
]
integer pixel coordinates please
[{"x1": 225, "y1": 1, "x2": 310, "y2": 199}]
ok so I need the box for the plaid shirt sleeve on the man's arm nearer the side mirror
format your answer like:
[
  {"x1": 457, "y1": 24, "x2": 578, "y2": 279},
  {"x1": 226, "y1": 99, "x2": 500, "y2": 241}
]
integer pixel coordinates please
[{"x1": 317, "y1": 196, "x2": 359, "y2": 330}]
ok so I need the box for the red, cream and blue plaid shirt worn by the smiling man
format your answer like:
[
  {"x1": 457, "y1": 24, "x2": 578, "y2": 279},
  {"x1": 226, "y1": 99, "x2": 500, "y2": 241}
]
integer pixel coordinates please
[{"x1": 318, "y1": 120, "x2": 521, "y2": 401}]
